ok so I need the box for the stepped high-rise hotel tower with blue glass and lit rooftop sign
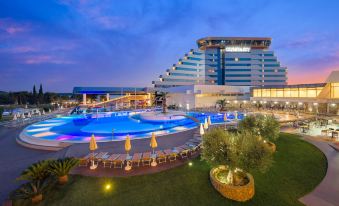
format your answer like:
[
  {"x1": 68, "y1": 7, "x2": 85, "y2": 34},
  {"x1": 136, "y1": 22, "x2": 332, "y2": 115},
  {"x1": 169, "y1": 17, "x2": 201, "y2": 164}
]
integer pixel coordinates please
[{"x1": 153, "y1": 37, "x2": 287, "y2": 87}]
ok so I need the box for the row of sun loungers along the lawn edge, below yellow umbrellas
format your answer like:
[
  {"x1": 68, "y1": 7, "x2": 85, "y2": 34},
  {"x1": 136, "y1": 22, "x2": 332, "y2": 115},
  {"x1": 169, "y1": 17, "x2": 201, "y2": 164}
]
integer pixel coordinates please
[{"x1": 79, "y1": 135, "x2": 201, "y2": 168}]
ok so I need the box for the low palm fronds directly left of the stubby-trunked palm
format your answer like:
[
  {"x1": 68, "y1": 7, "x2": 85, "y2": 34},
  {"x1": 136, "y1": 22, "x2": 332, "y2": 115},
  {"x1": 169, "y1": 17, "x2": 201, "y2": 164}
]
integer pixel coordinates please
[{"x1": 17, "y1": 160, "x2": 50, "y2": 181}]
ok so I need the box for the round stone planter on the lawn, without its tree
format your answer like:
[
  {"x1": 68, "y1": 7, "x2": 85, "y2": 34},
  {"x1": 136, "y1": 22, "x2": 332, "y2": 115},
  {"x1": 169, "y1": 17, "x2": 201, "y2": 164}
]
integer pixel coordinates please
[{"x1": 210, "y1": 166, "x2": 255, "y2": 202}]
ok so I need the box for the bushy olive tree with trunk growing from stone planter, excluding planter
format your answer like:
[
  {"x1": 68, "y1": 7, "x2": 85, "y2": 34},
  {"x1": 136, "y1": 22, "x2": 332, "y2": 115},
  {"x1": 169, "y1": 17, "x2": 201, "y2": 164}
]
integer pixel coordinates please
[{"x1": 201, "y1": 128, "x2": 273, "y2": 185}]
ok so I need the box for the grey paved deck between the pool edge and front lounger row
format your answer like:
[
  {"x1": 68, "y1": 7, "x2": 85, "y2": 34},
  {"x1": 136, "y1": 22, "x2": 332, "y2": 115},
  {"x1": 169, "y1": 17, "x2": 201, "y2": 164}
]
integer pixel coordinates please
[{"x1": 0, "y1": 126, "x2": 194, "y2": 203}]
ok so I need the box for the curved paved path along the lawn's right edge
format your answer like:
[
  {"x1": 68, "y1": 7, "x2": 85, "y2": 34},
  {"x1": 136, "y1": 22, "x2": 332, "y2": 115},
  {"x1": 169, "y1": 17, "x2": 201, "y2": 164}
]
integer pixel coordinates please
[{"x1": 282, "y1": 128, "x2": 339, "y2": 206}]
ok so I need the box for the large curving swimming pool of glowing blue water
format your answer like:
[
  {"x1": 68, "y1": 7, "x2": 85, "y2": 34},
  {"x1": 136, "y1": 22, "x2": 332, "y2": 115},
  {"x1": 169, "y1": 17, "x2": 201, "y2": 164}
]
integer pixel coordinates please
[{"x1": 23, "y1": 111, "x2": 243, "y2": 143}]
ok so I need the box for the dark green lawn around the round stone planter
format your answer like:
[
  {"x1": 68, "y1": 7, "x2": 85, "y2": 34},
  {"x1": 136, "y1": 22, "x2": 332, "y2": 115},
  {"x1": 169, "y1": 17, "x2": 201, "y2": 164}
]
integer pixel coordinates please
[{"x1": 14, "y1": 134, "x2": 327, "y2": 206}]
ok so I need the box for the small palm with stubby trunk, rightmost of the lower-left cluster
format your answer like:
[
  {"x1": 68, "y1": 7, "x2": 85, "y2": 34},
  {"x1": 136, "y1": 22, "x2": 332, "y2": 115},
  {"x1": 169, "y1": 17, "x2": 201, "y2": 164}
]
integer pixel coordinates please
[{"x1": 48, "y1": 157, "x2": 79, "y2": 185}]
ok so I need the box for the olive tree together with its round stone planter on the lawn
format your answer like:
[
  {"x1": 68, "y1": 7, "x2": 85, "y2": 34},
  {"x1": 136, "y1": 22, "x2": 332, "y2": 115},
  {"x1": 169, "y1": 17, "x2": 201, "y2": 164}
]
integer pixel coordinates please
[{"x1": 202, "y1": 128, "x2": 273, "y2": 202}]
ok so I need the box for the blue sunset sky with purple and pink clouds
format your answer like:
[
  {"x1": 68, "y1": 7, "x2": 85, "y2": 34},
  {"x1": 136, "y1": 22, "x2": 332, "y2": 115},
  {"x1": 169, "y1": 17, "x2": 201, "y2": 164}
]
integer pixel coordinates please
[{"x1": 0, "y1": 0, "x2": 339, "y2": 92}]
